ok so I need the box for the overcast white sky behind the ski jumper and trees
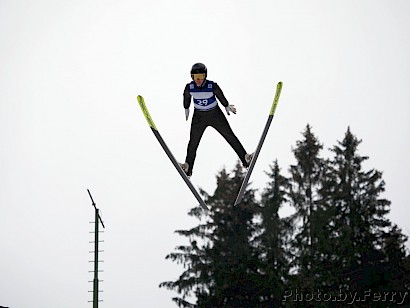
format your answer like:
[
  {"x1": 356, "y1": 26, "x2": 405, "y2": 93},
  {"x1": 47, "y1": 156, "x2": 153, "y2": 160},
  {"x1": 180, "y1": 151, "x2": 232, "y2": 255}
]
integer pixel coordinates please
[{"x1": 0, "y1": 0, "x2": 410, "y2": 308}]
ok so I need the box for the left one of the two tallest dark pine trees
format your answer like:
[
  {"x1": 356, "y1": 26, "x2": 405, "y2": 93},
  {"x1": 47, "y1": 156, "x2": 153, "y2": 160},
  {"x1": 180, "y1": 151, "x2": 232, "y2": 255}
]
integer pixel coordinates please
[{"x1": 290, "y1": 125, "x2": 325, "y2": 291}]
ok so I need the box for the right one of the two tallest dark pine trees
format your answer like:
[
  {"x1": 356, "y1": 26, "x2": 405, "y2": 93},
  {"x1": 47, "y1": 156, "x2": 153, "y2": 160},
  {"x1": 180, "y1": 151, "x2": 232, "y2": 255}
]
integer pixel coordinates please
[{"x1": 331, "y1": 128, "x2": 391, "y2": 291}]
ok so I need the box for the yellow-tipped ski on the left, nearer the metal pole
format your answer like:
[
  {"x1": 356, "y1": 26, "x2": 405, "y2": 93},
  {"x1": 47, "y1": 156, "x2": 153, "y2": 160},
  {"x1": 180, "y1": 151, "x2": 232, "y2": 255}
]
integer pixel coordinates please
[{"x1": 137, "y1": 95, "x2": 209, "y2": 210}]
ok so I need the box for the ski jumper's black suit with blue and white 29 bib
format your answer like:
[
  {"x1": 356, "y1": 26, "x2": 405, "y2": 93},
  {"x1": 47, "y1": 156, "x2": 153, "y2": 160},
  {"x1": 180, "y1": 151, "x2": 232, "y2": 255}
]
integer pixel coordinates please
[{"x1": 184, "y1": 80, "x2": 248, "y2": 175}]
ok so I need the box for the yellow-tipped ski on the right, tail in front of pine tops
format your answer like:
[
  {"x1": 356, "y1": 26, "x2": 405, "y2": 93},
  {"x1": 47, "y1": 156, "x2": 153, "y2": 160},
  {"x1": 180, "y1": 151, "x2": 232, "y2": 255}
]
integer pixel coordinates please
[{"x1": 234, "y1": 81, "x2": 282, "y2": 206}]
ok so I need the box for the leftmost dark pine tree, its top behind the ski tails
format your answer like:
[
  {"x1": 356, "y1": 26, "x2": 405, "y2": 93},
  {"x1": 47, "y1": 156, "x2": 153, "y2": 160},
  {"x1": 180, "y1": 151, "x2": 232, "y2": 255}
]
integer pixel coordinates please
[{"x1": 160, "y1": 164, "x2": 259, "y2": 307}]
